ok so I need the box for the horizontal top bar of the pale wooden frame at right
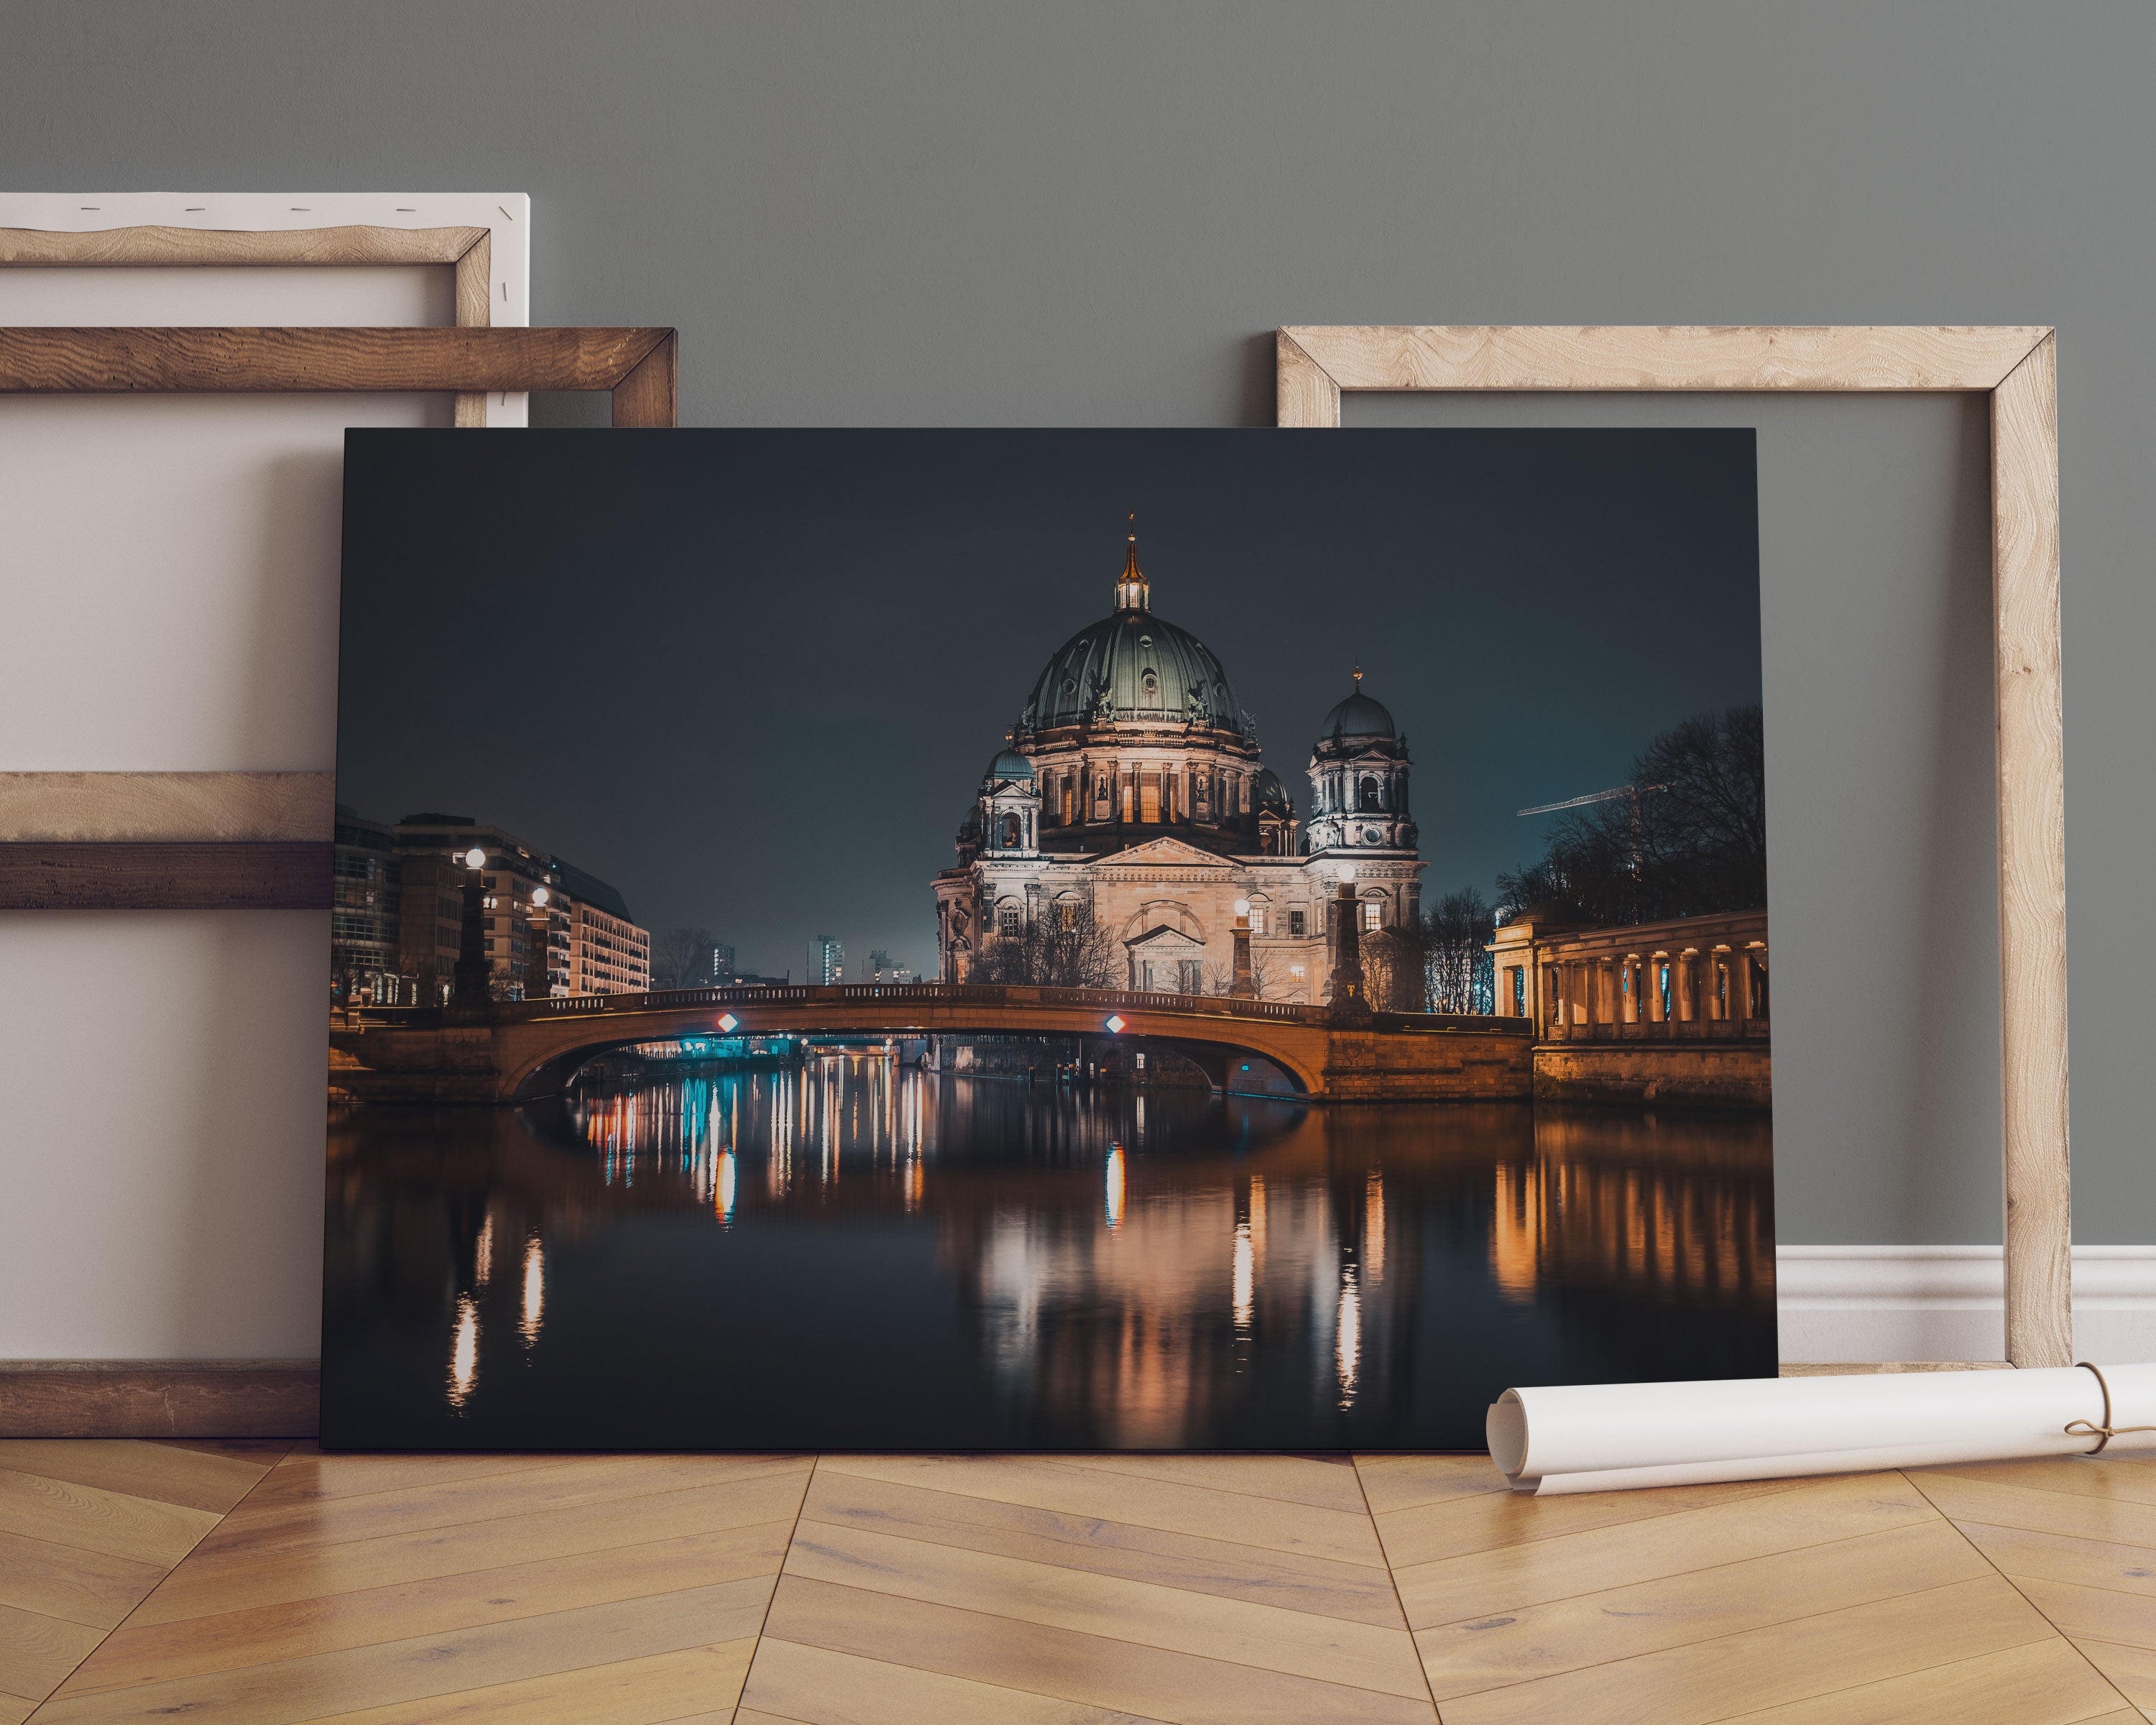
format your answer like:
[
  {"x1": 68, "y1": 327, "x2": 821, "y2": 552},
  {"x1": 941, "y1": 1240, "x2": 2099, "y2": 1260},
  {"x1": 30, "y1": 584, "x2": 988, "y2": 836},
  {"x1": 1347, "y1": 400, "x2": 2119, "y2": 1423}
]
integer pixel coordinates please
[{"x1": 1281, "y1": 323, "x2": 2050, "y2": 405}]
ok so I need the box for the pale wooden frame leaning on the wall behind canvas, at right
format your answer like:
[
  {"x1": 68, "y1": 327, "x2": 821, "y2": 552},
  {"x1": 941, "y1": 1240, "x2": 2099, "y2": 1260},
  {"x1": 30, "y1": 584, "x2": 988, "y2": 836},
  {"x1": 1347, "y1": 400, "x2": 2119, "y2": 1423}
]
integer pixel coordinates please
[{"x1": 1276, "y1": 323, "x2": 2074, "y2": 1367}]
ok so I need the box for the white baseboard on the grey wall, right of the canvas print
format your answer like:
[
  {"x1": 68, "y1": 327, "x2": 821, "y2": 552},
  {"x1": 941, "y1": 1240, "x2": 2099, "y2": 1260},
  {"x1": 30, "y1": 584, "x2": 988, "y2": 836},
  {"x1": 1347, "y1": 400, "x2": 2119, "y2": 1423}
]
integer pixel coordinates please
[{"x1": 1774, "y1": 1246, "x2": 2156, "y2": 1363}]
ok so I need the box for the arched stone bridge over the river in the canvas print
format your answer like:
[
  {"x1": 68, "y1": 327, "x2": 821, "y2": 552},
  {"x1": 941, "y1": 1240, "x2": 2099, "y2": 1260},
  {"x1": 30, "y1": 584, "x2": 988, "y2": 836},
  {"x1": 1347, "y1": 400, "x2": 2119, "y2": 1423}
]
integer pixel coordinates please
[{"x1": 330, "y1": 983, "x2": 1533, "y2": 1102}]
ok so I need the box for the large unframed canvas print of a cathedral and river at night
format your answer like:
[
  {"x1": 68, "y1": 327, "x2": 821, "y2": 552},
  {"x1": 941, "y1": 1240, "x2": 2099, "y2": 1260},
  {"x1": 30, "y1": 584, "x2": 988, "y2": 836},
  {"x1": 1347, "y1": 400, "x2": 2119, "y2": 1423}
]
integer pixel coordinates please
[{"x1": 321, "y1": 429, "x2": 1777, "y2": 1449}]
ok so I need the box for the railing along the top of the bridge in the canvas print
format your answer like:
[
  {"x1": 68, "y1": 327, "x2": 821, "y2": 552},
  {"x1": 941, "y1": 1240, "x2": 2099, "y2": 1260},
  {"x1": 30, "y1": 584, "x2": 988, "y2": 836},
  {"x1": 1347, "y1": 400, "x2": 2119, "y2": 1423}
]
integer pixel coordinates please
[{"x1": 349, "y1": 983, "x2": 1535, "y2": 1037}]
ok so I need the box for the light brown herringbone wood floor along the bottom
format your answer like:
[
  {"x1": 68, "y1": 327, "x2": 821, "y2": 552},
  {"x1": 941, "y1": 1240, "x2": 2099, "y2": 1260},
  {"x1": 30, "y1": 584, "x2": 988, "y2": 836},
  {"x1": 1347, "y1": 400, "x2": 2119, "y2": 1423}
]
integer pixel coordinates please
[{"x1": 0, "y1": 1443, "x2": 2156, "y2": 1725}]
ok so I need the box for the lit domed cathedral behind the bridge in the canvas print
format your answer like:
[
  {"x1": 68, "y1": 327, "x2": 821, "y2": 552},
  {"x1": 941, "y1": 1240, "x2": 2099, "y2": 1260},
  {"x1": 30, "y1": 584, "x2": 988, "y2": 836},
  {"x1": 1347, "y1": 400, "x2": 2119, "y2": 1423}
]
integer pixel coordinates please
[{"x1": 936, "y1": 535, "x2": 1423, "y2": 1000}]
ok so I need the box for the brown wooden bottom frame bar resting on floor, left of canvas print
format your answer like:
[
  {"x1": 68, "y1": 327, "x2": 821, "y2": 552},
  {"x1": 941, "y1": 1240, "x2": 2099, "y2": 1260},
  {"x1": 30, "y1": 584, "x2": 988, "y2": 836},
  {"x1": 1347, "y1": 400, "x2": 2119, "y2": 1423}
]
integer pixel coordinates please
[{"x1": 0, "y1": 1361, "x2": 321, "y2": 1438}]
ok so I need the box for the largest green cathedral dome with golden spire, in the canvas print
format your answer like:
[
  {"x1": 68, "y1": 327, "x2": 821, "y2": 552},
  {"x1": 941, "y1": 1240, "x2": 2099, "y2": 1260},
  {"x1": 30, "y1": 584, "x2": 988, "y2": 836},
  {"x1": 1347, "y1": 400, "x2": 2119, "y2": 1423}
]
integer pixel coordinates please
[{"x1": 1020, "y1": 537, "x2": 1244, "y2": 733}]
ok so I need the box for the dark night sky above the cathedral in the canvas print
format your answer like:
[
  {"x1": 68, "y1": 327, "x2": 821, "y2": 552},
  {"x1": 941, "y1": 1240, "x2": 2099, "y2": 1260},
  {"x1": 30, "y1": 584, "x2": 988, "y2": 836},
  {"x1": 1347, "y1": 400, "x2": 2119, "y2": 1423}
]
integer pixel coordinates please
[{"x1": 336, "y1": 429, "x2": 1772, "y2": 981}]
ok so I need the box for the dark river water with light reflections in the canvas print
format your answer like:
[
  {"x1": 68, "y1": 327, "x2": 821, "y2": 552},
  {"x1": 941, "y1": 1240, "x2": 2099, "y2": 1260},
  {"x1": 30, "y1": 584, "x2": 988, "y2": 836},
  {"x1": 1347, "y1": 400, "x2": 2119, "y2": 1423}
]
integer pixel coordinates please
[{"x1": 323, "y1": 1057, "x2": 1774, "y2": 1449}]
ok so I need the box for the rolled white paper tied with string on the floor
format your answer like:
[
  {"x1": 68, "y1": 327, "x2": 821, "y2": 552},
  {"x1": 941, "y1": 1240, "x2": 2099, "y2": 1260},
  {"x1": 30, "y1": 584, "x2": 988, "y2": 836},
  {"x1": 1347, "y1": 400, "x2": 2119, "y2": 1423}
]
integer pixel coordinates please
[{"x1": 1485, "y1": 1365, "x2": 2156, "y2": 1496}]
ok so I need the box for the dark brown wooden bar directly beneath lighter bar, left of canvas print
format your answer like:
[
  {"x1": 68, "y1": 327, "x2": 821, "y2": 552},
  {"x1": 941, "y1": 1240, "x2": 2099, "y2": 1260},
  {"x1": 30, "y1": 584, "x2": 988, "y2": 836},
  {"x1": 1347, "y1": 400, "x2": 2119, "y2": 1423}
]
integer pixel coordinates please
[{"x1": 0, "y1": 841, "x2": 330, "y2": 910}]
